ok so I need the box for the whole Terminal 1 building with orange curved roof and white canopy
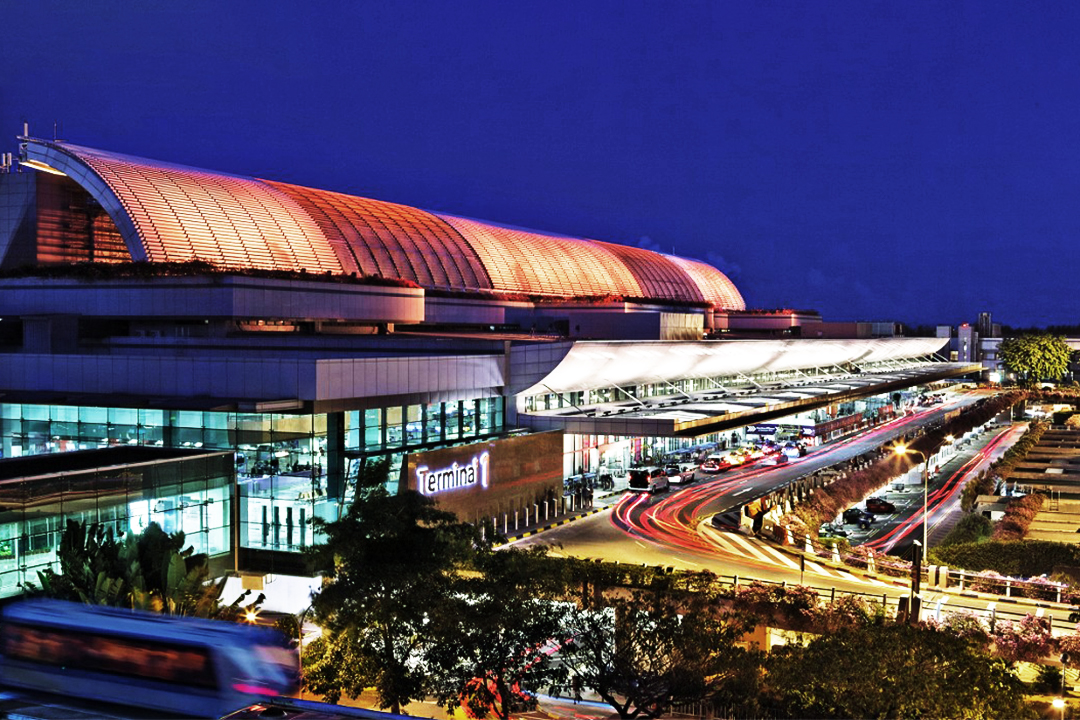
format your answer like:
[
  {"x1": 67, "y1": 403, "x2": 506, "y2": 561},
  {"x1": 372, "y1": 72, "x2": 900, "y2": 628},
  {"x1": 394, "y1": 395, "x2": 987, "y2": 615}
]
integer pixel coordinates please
[{"x1": 0, "y1": 137, "x2": 977, "y2": 596}]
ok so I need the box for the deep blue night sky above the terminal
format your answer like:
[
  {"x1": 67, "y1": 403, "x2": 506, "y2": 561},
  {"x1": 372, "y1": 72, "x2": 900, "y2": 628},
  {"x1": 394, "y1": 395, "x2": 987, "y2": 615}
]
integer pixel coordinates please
[{"x1": 0, "y1": 0, "x2": 1080, "y2": 326}]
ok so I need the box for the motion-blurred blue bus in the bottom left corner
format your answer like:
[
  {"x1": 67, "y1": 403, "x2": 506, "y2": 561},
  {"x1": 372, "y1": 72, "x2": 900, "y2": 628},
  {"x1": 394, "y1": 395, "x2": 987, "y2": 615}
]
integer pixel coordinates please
[{"x1": 0, "y1": 600, "x2": 299, "y2": 718}]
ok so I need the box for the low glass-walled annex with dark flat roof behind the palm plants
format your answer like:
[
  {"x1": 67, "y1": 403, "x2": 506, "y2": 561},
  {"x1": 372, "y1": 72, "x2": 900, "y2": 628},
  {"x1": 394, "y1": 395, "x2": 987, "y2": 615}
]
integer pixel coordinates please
[{"x1": 0, "y1": 454, "x2": 233, "y2": 597}]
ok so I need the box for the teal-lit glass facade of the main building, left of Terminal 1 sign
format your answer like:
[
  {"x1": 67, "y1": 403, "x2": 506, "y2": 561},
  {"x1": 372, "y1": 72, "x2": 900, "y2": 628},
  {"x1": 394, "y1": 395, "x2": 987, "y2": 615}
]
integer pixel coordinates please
[{"x1": 0, "y1": 397, "x2": 505, "y2": 552}]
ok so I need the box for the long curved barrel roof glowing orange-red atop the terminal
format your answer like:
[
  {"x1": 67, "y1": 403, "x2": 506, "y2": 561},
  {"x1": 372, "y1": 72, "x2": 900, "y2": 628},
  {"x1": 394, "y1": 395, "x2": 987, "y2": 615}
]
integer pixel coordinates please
[{"x1": 19, "y1": 139, "x2": 745, "y2": 310}]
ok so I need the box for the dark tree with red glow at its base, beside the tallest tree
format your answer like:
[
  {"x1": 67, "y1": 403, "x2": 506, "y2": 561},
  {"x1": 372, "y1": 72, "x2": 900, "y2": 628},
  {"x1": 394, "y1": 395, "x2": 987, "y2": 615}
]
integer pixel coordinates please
[{"x1": 430, "y1": 547, "x2": 567, "y2": 720}]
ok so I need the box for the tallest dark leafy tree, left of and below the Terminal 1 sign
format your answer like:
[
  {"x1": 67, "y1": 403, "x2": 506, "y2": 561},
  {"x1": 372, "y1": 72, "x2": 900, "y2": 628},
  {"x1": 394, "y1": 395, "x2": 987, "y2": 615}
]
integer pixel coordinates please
[{"x1": 305, "y1": 461, "x2": 475, "y2": 712}]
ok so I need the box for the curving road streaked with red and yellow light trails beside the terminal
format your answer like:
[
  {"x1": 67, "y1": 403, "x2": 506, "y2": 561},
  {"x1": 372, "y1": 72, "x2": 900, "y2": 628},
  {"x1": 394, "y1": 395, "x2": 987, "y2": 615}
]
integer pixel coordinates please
[{"x1": 515, "y1": 393, "x2": 1068, "y2": 627}]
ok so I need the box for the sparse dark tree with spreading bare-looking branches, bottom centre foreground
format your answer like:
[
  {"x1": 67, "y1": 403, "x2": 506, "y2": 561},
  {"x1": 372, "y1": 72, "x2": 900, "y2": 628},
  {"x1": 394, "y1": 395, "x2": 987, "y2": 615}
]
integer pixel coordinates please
[{"x1": 561, "y1": 581, "x2": 757, "y2": 718}]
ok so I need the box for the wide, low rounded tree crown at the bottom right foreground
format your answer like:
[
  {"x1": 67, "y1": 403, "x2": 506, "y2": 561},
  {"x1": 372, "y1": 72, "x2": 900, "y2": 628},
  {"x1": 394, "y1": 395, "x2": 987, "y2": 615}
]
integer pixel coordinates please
[{"x1": 762, "y1": 624, "x2": 1035, "y2": 718}]
